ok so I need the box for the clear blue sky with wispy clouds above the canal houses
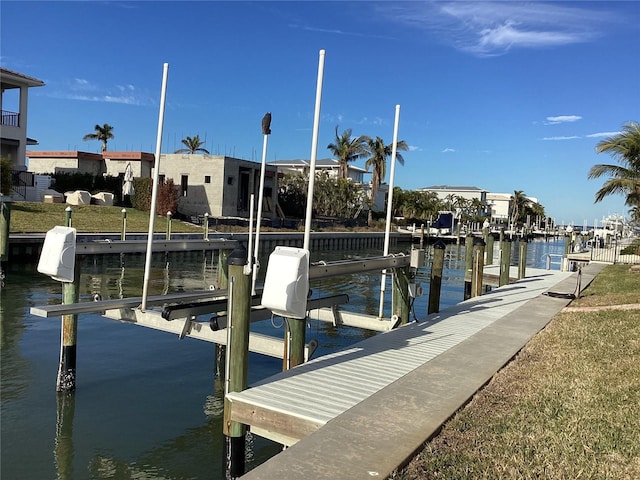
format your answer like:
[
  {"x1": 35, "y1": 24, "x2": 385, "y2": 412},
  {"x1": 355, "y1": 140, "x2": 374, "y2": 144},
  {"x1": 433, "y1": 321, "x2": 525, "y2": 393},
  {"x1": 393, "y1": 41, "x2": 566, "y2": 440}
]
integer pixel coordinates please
[{"x1": 0, "y1": 0, "x2": 640, "y2": 225}]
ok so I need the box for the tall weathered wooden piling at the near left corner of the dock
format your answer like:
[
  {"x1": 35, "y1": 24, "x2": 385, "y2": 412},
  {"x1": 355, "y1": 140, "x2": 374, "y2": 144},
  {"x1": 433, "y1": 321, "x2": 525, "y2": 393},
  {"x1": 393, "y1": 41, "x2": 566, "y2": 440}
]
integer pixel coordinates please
[{"x1": 222, "y1": 247, "x2": 251, "y2": 479}]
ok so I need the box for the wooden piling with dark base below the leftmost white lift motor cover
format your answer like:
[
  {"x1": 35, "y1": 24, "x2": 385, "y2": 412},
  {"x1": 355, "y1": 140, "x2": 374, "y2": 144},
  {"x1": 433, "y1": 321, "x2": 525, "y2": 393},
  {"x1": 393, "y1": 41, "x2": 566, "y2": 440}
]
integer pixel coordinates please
[{"x1": 56, "y1": 207, "x2": 80, "y2": 392}]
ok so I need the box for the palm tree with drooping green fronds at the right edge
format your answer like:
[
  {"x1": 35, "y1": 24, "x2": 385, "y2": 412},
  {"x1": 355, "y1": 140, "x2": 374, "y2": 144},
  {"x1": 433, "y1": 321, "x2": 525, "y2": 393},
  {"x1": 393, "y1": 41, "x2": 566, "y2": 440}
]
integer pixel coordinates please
[{"x1": 588, "y1": 122, "x2": 640, "y2": 207}]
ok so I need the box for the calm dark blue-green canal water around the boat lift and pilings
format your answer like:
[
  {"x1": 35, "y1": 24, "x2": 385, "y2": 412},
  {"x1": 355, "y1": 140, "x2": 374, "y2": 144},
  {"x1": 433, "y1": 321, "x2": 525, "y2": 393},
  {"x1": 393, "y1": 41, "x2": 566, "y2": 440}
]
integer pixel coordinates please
[{"x1": 0, "y1": 240, "x2": 564, "y2": 480}]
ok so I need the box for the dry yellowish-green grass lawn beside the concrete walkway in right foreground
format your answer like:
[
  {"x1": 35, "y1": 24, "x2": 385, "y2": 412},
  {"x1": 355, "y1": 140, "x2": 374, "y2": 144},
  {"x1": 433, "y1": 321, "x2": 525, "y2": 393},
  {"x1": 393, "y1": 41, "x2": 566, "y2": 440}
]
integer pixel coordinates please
[{"x1": 392, "y1": 265, "x2": 640, "y2": 480}]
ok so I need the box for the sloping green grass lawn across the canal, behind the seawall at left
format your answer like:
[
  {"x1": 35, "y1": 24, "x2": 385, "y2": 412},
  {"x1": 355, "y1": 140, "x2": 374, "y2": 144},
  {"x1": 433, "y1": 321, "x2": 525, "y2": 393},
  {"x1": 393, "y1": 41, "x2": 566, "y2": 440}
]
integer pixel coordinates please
[{"x1": 10, "y1": 202, "x2": 203, "y2": 233}]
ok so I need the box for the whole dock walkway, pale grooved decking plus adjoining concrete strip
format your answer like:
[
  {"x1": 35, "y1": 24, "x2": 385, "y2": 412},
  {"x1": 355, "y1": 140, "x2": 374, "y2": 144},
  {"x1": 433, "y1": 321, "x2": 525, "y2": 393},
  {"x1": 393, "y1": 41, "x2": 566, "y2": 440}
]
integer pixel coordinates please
[{"x1": 229, "y1": 264, "x2": 604, "y2": 480}]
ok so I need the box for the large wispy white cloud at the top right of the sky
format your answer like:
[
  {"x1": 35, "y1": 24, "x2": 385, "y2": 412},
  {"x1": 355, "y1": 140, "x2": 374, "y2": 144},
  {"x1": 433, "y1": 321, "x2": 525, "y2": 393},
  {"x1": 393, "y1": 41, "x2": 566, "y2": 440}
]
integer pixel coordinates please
[{"x1": 377, "y1": 1, "x2": 613, "y2": 56}]
